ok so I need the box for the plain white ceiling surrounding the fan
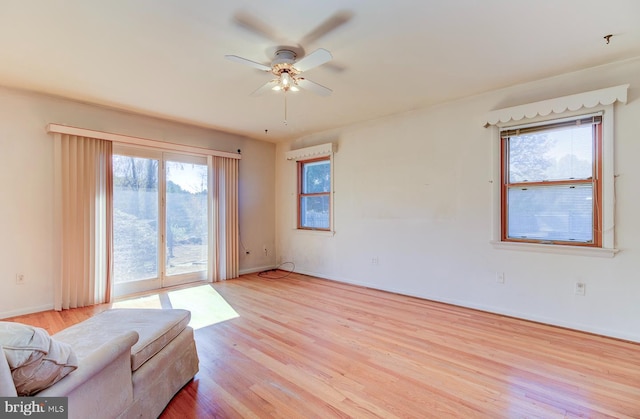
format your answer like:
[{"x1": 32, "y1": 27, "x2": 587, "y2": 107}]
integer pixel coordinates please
[{"x1": 0, "y1": 0, "x2": 640, "y2": 141}]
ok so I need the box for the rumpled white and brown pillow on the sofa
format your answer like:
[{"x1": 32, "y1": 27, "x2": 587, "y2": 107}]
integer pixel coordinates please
[{"x1": 0, "y1": 322, "x2": 78, "y2": 396}]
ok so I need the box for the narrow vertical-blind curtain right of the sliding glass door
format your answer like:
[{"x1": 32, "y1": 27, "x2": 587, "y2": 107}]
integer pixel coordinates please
[{"x1": 209, "y1": 156, "x2": 240, "y2": 281}]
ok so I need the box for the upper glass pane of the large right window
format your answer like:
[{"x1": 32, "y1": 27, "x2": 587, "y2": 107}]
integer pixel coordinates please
[{"x1": 508, "y1": 125, "x2": 593, "y2": 183}]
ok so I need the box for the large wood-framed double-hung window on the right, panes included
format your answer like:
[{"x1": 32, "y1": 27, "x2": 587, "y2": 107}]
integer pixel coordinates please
[{"x1": 500, "y1": 114, "x2": 603, "y2": 247}]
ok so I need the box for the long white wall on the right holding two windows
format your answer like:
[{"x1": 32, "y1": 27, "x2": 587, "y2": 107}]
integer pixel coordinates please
[{"x1": 276, "y1": 59, "x2": 640, "y2": 341}]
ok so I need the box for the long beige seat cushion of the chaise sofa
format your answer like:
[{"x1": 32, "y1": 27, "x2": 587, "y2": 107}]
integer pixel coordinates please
[{"x1": 54, "y1": 308, "x2": 191, "y2": 371}]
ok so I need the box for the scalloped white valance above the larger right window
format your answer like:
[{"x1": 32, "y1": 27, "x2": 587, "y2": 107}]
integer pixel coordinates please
[{"x1": 484, "y1": 84, "x2": 629, "y2": 127}]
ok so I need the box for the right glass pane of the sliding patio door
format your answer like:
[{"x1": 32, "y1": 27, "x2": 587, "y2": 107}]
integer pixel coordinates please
[{"x1": 166, "y1": 161, "x2": 207, "y2": 275}]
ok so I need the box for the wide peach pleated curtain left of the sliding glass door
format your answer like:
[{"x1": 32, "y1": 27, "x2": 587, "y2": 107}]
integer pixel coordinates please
[{"x1": 54, "y1": 133, "x2": 113, "y2": 310}]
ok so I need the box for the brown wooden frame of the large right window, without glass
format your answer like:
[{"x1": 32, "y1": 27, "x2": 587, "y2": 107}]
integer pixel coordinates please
[{"x1": 499, "y1": 112, "x2": 604, "y2": 248}]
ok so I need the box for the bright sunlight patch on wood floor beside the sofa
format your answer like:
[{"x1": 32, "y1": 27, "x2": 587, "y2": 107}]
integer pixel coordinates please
[{"x1": 112, "y1": 285, "x2": 239, "y2": 329}]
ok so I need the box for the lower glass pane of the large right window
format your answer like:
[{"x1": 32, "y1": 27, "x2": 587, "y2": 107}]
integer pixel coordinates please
[{"x1": 507, "y1": 185, "x2": 593, "y2": 243}]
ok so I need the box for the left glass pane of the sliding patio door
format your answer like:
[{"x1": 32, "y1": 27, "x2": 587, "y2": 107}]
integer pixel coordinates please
[{"x1": 113, "y1": 155, "x2": 158, "y2": 283}]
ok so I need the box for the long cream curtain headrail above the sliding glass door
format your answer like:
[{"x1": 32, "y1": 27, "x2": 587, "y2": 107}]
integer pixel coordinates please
[{"x1": 47, "y1": 123, "x2": 242, "y2": 160}]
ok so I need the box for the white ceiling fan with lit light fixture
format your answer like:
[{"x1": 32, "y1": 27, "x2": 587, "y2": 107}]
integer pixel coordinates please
[{"x1": 225, "y1": 47, "x2": 333, "y2": 96}]
